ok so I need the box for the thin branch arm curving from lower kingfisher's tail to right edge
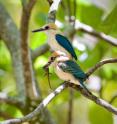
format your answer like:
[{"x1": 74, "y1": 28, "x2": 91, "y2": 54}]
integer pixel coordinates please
[{"x1": 86, "y1": 58, "x2": 117, "y2": 77}]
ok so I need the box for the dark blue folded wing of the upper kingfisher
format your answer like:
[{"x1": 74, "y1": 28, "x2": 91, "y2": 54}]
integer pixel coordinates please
[{"x1": 55, "y1": 34, "x2": 77, "y2": 60}]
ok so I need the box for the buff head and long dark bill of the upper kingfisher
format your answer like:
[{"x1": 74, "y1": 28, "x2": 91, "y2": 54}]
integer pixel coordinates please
[{"x1": 32, "y1": 23, "x2": 58, "y2": 32}]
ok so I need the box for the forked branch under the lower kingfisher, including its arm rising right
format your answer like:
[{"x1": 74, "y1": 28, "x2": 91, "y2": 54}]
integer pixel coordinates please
[{"x1": 1, "y1": 59, "x2": 117, "y2": 124}]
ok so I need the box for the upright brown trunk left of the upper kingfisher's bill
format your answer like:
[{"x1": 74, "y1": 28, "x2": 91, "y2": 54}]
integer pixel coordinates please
[{"x1": 20, "y1": 0, "x2": 39, "y2": 99}]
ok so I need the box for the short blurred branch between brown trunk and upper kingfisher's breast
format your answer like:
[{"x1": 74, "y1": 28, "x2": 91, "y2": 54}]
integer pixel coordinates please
[{"x1": 31, "y1": 44, "x2": 49, "y2": 60}]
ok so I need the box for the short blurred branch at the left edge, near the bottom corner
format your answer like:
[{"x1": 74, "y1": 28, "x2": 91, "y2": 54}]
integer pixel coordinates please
[{"x1": 0, "y1": 93, "x2": 24, "y2": 108}]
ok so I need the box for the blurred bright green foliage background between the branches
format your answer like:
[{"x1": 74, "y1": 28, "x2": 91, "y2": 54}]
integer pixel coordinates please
[{"x1": 0, "y1": 0, "x2": 117, "y2": 124}]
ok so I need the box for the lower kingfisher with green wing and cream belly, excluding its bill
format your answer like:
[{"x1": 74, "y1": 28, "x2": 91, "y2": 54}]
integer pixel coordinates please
[{"x1": 50, "y1": 51, "x2": 88, "y2": 91}]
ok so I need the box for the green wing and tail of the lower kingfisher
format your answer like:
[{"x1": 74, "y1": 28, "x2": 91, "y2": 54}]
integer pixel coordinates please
[{"x1": 60, "y1": 60, "x2": 88, "y2": 90}]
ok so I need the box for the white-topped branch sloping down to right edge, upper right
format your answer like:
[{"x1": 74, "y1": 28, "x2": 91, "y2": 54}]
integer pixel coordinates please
[{"x1": 76, "y1": 20, "x2": 117, "y2": 46}]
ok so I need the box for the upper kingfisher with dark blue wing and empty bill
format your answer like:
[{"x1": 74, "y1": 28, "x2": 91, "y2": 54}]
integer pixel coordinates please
[{"x1": 32, "y1": 23, "x2": 77, "y2": 60}]
